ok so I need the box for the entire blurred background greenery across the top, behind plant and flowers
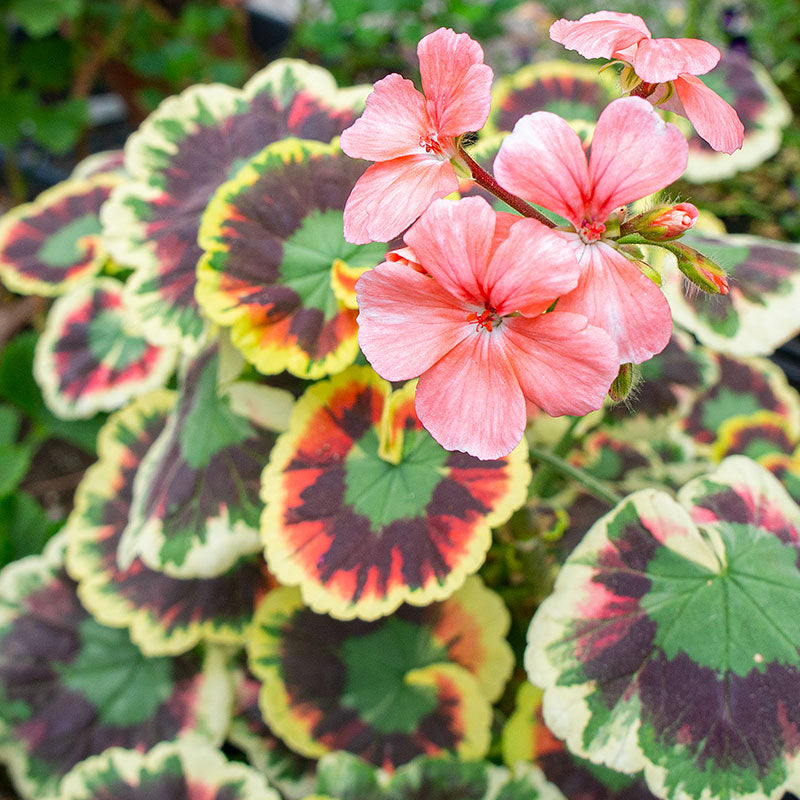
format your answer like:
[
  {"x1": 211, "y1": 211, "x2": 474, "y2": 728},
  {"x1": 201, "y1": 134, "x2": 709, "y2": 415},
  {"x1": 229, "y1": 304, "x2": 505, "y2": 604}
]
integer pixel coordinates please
[{"x1": 0, "y1": 0, "x2": 800, "y2": 231}]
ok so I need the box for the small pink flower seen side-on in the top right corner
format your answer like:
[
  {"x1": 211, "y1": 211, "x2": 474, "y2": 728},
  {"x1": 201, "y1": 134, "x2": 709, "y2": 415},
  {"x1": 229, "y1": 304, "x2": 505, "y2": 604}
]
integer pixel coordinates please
[{"x1": 550, "y1": 11, "x2": 744, "y2": 153}]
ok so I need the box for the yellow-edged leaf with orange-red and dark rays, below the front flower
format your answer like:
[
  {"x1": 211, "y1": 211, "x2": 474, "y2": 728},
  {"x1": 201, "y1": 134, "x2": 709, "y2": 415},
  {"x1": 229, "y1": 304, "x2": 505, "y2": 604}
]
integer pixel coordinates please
[{"x1": 261, "y1": 367, "x2": 530, "y2": 619}]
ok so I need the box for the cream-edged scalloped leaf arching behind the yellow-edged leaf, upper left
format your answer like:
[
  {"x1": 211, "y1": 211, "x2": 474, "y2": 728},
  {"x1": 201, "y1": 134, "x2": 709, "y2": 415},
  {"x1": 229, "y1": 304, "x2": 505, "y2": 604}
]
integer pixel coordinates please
[{"x1": 103, "y1": 59, "x2": 366, "y2": 350}]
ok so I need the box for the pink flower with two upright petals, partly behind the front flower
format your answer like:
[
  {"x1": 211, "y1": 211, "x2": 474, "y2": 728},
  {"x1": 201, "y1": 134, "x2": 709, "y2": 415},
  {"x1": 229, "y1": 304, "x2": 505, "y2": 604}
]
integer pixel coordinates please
[{"x1": 494, "y1": 97, "x2": 688, "y2": 364}]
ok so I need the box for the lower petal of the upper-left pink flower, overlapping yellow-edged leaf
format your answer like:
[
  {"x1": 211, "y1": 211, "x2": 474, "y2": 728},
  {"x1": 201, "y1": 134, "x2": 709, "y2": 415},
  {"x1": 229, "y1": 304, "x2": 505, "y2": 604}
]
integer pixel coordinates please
[{"x1": 344, "y1": 155, "x2": 458, "y2": 244}]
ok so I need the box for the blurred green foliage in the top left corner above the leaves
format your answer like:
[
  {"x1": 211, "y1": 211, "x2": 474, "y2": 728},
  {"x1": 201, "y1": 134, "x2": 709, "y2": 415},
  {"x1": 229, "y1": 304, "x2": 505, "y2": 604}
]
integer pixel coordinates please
[{"x1": 0, "y1": 0, "x2": 250, "y2": 202}]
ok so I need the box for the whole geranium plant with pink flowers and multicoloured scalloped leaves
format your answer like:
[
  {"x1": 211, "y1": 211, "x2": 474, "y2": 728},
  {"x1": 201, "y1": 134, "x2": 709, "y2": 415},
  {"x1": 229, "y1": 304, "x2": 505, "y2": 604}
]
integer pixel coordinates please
[{"x1": 0, "y1": 12, "x2": 800, "y2": 800}]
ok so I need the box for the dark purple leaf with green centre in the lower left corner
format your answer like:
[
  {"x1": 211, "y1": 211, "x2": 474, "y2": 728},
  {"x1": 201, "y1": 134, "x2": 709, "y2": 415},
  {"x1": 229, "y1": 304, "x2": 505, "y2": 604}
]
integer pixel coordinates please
[{"x1": 0, "y1": 535, "x2": 229, "y2": 798}]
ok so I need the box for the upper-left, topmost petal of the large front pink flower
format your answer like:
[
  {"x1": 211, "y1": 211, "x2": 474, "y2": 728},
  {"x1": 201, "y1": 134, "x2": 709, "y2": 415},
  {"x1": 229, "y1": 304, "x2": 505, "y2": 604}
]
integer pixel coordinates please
[{"x1": 404, "y1": 197, "x2": 495, "y2": 310}]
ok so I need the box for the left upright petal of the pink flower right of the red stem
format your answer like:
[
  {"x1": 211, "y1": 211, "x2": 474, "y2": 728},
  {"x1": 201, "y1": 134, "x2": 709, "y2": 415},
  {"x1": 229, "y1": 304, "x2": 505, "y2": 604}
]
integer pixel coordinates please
[{"x1": 494, "y1": 111, "x2": 591, "y2": 227}]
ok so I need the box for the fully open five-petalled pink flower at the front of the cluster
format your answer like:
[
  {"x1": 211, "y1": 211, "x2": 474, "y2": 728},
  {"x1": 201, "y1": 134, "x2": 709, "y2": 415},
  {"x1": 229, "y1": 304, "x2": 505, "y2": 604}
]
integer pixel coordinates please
[{"x1": 356, "y1": 197, "x2": 619, "y2": 459}]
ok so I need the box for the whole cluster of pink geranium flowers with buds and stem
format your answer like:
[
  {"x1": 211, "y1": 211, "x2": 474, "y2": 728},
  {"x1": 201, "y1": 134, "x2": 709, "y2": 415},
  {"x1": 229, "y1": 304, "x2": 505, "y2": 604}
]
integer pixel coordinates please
[{"x1": 341, "y1": 21, "x2": 742, "y2": 459}]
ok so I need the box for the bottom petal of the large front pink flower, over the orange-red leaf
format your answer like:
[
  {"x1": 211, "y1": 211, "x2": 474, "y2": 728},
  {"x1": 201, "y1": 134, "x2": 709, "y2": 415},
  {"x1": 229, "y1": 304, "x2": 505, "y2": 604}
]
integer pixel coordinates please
[{"x1": 415, "y1": 329, "x2": 526, "y2": 459}]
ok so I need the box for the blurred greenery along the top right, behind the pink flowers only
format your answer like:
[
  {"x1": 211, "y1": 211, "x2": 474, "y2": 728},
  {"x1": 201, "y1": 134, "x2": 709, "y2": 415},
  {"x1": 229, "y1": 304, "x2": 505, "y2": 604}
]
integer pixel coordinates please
[{"x1": 287, "y1": 0, "x2": 800, "y2": 241}]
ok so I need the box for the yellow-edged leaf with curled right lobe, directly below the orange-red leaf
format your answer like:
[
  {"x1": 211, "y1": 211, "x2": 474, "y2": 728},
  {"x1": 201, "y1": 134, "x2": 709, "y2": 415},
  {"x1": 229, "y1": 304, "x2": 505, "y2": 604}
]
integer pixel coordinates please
[{"x1": 248, "y1": 579, "x2": 510, "y2": 766}]
